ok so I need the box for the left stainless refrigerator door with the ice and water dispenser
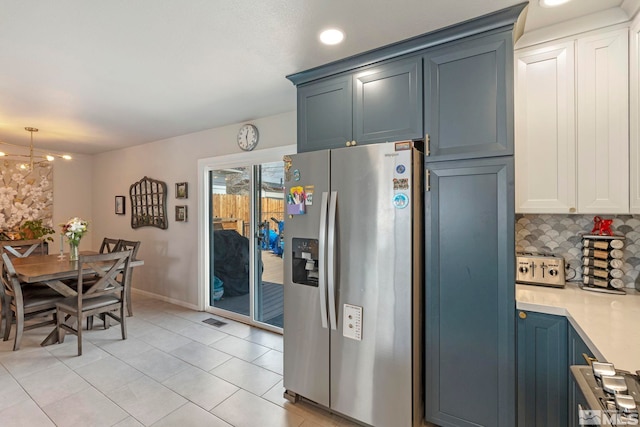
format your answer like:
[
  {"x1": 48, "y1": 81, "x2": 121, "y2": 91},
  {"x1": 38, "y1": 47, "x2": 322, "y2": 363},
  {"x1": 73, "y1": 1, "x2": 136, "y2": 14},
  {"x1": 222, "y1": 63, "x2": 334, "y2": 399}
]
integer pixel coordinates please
[{"x1": 284, "y1": 151, "x2": 330, "y2": 406}]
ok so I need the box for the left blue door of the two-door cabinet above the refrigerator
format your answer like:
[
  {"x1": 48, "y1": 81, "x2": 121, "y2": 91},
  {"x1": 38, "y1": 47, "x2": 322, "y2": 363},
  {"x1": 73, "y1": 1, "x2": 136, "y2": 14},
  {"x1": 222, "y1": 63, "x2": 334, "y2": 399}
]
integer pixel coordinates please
[{"x1": 298, "y1": 75, "x2": 352, "y2": 152}]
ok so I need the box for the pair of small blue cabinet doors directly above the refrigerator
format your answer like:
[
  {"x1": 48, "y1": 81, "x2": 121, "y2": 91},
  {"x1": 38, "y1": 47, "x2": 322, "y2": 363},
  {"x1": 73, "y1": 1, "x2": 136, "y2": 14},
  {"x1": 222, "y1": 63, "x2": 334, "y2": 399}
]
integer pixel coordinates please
[{"x1": 298, "y1": 56, "x2": 423, "y2": 152}]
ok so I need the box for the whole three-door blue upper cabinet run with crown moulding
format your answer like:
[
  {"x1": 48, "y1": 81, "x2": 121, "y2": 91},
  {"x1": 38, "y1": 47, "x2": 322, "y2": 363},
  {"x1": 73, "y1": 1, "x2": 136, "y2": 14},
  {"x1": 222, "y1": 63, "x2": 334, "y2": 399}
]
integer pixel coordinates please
[{"x1": 287, "y1": 2, "x2": 527, "y2": 155}]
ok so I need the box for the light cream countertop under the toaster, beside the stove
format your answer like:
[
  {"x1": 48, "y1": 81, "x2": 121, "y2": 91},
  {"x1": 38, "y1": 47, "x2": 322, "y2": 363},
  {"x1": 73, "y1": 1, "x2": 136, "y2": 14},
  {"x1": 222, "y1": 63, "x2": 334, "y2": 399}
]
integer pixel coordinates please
[{"x1": 516, "y1": 283, "x2": 640, "y2": 372}]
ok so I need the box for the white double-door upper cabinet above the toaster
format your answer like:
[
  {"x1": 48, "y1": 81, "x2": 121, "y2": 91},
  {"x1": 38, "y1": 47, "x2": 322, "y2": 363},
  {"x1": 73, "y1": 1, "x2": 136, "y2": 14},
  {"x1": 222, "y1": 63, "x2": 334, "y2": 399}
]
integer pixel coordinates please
[{"x1": 515, "y1": 28, "x2": 629, "y2": 214}]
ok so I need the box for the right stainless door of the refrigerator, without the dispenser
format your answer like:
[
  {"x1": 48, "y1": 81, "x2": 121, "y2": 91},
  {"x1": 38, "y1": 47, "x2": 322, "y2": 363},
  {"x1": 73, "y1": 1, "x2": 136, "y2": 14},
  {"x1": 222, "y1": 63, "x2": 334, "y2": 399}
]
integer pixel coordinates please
[{"x1": 330, "y1": 143, "x2": 422, "y2": 426}]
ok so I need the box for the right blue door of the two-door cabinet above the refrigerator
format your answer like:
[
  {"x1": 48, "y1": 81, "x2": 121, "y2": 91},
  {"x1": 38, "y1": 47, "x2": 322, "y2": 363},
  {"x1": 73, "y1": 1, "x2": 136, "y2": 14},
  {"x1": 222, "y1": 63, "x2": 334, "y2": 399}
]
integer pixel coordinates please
[{"x1": 353, "y1": 57, "x2": 423, "y2": 144}]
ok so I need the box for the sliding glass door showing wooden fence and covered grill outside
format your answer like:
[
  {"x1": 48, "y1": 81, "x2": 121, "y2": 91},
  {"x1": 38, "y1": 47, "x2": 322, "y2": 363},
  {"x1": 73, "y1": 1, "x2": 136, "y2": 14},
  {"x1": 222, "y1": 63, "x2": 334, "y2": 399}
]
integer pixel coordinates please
[{"x1": 205, "y1": 149, "x2": 285, "y2": 330}]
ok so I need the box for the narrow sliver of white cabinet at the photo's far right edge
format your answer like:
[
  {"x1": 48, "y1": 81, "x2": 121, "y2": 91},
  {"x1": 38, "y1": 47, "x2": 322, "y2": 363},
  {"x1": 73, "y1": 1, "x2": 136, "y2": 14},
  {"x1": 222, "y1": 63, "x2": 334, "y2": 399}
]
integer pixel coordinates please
[{"x1": 629, "y1": 15, "x2": 640, "y2": 214}]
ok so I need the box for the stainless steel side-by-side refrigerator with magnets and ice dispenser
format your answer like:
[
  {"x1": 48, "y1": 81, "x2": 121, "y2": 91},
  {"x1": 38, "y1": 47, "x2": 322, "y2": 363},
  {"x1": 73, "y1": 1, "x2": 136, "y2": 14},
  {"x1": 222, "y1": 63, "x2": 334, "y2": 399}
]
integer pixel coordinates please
[{"x1": 284, "y1": 142, "x2": 423, "y2": 427}]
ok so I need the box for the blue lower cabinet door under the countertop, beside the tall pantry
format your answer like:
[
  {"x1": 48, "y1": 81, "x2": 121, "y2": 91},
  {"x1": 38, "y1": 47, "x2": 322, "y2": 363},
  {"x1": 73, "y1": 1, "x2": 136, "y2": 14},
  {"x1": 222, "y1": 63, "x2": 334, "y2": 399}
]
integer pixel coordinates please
[{"x1": 517, "y1": 311, "x2": 569, "y2": 427}]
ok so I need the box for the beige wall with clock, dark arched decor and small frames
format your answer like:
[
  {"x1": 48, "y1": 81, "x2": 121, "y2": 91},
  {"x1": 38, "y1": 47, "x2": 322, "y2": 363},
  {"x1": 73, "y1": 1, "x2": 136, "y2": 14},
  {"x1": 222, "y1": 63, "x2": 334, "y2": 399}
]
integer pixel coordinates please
[{"x1": 90, "y1": 111, "x2": 296, "y2": 308}]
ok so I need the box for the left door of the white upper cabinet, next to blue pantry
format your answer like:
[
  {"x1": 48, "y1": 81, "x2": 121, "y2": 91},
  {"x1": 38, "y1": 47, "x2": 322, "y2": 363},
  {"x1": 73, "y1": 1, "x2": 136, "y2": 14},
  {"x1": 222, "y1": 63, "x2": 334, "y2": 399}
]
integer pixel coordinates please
[{"x1": 515, "y1": 41, "x2": 576, "y2": 213}]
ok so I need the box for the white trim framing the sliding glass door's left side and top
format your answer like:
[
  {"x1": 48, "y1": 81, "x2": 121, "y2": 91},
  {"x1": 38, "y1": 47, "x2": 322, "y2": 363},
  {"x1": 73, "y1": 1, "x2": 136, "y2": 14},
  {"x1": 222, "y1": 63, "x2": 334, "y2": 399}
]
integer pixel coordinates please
[{"x1": 197, "y1": 144, "x2": 297, "y2": 327}]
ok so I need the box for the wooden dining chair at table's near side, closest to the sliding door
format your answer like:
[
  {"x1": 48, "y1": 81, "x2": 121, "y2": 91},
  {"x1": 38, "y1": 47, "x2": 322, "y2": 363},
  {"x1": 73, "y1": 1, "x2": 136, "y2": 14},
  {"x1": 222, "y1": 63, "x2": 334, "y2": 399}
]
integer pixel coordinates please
[{"x1": 56, "y1": 251, "x2": 131, "y2": 356}]
